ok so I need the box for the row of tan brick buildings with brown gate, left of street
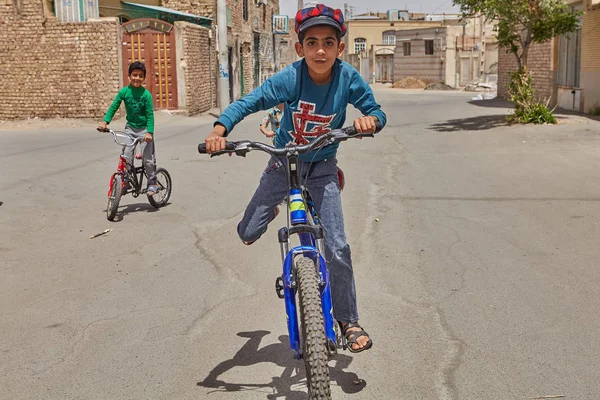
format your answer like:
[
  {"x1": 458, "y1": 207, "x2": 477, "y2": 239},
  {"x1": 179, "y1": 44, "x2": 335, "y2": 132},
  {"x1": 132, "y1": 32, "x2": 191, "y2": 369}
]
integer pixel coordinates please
[{"x1": 0, "y1": 0, "x2": 279, "y2": 119}]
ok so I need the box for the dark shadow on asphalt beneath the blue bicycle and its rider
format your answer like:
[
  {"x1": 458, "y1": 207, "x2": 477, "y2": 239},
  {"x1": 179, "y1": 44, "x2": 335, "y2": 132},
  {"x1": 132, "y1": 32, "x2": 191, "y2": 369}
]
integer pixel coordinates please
[{"x1": 197, "y1": 330, "x2": 367, "y2": 400}]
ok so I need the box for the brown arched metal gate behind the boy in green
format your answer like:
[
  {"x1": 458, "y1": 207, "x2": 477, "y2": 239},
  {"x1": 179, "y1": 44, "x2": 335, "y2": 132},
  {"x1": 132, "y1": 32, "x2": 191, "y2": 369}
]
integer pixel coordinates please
[{"x1": 122, "y1": 18, "x2": 177, "y2": 110}]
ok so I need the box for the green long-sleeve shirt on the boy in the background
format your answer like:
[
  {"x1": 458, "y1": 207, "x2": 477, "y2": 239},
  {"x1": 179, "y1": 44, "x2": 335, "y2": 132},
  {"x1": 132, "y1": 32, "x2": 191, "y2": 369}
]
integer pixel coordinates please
[{"x1": 104, "y1": 85, "x2": 154, "y2": 133}]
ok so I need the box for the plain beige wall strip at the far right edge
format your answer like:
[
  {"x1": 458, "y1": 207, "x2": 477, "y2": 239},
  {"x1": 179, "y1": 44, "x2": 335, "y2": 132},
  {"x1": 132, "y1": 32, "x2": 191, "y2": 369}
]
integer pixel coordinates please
[{"x1": 580, "y1": 0, "x2": 600, "y2": 112}]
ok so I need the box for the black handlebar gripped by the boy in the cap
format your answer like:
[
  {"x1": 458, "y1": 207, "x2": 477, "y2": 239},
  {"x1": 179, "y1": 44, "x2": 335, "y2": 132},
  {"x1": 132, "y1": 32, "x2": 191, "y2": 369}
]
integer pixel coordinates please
[{"x1": 198, "y1": 121, "x2": 382, "y2": 157}]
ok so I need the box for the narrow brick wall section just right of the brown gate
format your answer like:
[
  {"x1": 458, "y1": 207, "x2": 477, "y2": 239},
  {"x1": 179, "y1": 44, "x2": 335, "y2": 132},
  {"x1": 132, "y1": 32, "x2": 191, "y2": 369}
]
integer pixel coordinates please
[{"x1": 175, "y1": 22, "x2": 217, "y2": 115}]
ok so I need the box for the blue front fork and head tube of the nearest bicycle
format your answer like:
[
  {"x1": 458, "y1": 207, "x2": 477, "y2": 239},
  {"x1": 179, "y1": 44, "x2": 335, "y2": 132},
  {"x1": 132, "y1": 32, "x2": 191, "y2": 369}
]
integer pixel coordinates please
[{"x1": 278, "y1": 155, "x2": 337, "y2": 359}]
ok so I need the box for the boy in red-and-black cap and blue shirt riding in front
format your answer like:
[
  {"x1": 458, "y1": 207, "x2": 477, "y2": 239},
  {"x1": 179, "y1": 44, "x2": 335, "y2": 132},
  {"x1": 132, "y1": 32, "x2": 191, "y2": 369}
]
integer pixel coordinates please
[{"x1": 205, "y1": 4, "x2": 386, "y2": 352}]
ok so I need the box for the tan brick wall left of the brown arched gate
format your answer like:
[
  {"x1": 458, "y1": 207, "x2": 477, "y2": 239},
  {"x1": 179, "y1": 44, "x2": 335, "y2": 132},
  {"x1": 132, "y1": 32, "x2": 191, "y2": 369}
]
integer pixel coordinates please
[{"x1": 0, "y1": 0, "x2": 121, "y2": 119}]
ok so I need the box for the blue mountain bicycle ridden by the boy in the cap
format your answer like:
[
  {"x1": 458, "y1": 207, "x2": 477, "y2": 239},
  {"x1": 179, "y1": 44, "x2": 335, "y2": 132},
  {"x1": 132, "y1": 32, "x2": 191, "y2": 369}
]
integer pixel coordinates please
[{"x1": 198, "y1": 126, "x2": 381, "y2": 399}]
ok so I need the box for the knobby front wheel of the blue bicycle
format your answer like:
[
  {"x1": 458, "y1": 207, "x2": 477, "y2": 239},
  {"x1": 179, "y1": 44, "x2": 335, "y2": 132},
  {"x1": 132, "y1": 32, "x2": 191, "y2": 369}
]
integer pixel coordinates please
[{"x1": 296, "y1": 257, "x2": 331, "y2": 400}]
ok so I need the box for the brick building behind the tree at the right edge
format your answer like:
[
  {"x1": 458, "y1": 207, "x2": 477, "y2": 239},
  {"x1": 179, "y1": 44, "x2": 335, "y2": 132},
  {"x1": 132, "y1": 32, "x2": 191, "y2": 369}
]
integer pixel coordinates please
[{"x1": 498, "y1": 0, "x2": 600, "y2": 112}]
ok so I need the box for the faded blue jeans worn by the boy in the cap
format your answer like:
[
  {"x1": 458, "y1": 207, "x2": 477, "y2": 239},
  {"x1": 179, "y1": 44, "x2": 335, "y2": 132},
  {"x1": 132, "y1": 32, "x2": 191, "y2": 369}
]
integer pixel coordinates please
[{"x1": 237, "y1": 157, "x2": 358, "y2": 322}]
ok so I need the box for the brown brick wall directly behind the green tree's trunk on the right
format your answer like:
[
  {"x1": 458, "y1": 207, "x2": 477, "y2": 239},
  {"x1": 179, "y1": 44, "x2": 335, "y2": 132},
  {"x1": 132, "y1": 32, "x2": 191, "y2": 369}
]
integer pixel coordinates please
[{"x1": 498, "y1": 40, "x2": 556, "y2": 104}]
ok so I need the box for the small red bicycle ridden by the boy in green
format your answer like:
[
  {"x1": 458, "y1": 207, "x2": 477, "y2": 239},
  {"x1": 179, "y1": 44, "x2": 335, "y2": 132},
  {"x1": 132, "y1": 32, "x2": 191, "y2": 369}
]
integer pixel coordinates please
[{"x1": 98, "y1": 129, "x2": 172, "y2": 221}]
